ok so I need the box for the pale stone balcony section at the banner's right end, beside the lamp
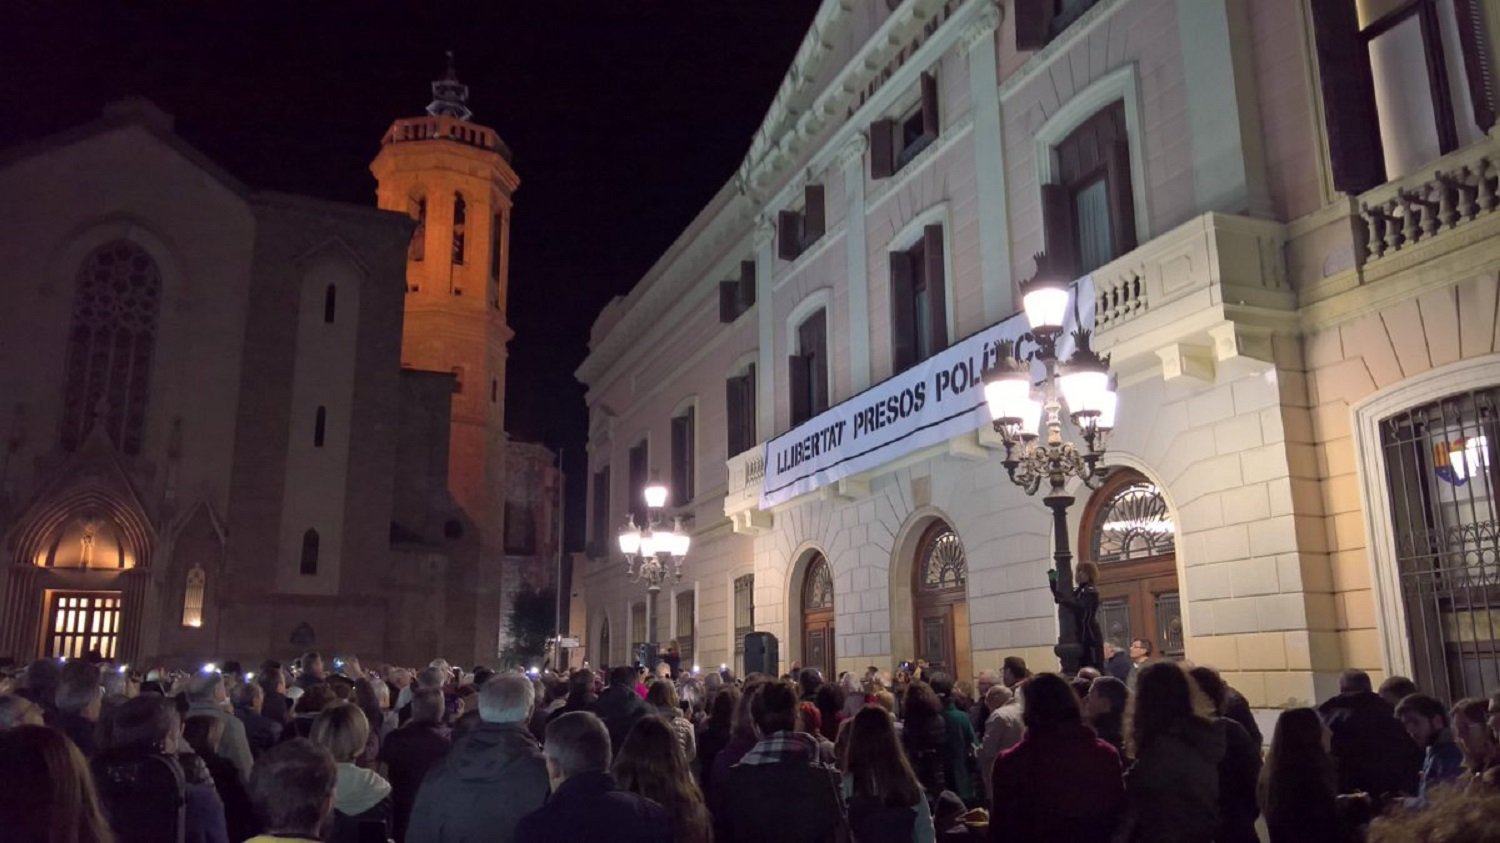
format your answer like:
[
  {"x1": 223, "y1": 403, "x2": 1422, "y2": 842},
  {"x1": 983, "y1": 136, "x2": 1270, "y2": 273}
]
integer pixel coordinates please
[{"x1": 1094, "y1": 213, "x2": 1296, "y2": 380}]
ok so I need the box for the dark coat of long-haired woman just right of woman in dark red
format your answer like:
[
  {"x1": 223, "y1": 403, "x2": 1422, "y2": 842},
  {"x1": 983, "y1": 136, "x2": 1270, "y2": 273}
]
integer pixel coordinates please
[{"x1": 1125, "y1": 717, "x2": 1224, "y2": 843}]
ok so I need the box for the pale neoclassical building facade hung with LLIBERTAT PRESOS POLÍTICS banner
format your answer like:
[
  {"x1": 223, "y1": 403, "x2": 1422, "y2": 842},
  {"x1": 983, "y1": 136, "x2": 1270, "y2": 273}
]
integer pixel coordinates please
[{"x1": 576, "y1": 0, "x2": 1500, "y2": 708}]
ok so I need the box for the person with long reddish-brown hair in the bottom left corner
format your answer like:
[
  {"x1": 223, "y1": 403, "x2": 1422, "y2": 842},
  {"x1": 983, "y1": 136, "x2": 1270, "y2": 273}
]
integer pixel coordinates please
[{"x1": 0, "y1": 723, "x2": 116, "y2": 843}]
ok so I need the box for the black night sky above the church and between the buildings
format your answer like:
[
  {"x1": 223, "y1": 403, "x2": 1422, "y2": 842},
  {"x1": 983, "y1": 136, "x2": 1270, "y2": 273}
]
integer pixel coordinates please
[{"x1": 0, "y1": 0, "x2": 818, "y2": 548}]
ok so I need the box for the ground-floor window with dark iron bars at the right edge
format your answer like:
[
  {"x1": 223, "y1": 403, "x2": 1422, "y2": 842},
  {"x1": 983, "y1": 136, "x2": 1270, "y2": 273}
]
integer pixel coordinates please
[{"x1": 1380, "y1": 389, "x2": 1500, "y2": 699}]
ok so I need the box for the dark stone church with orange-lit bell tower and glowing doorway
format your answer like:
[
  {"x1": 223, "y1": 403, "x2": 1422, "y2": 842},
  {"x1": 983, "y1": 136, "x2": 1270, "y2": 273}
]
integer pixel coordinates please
[{"x1": 0, "y1": 65, "x2": 551, "y2": 663}]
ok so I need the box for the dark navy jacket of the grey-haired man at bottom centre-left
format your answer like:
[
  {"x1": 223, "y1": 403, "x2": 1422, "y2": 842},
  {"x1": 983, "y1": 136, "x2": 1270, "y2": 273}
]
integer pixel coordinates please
[{"x1": 515, "y1": 771, "x2": 672, "y2": 843}]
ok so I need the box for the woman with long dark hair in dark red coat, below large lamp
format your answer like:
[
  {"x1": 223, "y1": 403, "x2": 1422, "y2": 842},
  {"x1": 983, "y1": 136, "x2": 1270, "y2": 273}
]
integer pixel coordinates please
[{"x1": 990, "y1": 674, "x2": 1125, "y2": 843}]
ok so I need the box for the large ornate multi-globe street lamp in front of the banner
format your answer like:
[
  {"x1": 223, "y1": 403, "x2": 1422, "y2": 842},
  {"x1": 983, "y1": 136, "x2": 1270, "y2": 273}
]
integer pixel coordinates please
[{"x1": 984, "y1": 267, "x2": 1118, "y2": 674}]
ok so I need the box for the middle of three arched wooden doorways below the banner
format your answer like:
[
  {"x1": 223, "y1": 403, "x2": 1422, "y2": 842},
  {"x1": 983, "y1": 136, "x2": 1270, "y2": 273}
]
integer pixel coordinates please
[{"x1": 912, "y1": 521, "x2": 969, "y2": 677}]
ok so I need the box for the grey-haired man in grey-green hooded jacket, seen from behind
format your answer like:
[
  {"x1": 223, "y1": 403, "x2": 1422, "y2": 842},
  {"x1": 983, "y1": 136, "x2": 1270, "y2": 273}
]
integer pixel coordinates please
[{"x1": 407, "y1": 674, "x2": 549, "y2": 843}]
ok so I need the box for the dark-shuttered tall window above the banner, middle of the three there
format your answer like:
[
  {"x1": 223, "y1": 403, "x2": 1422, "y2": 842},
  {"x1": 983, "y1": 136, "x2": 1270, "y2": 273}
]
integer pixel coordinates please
[{"x1": 891, "y1": 225, "x2": 948, "y2": 372}]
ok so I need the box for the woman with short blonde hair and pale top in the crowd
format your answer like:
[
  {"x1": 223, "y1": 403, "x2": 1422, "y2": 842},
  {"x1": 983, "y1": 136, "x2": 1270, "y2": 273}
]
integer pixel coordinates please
[{"x1": 309, "y1": 702, "x2": 392, "y2": 843}]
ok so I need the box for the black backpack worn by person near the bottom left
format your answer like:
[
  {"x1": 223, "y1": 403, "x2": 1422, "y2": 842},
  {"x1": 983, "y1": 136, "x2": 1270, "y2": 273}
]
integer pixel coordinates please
[{"x1": 93, "y1": 753, "x2": 188, "y2": 843}]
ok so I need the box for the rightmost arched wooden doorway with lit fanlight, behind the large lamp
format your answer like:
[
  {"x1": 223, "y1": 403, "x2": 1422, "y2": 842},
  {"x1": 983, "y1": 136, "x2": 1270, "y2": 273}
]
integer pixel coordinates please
[{"x1": 1079, "y1": 468, "x2": 1184, "y2": 659}]
